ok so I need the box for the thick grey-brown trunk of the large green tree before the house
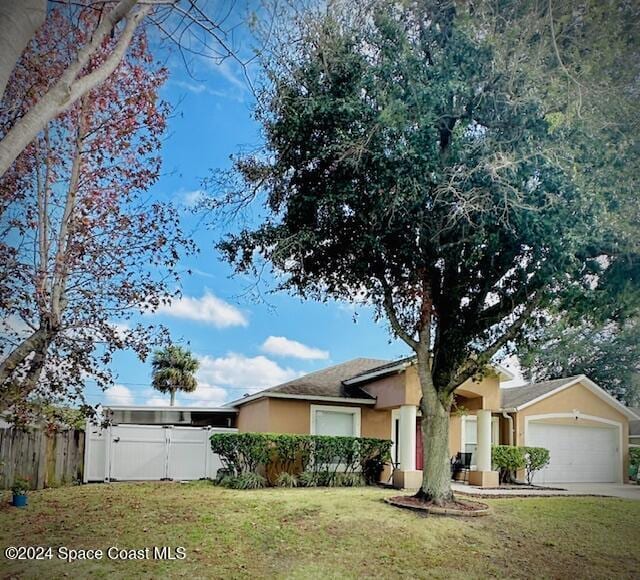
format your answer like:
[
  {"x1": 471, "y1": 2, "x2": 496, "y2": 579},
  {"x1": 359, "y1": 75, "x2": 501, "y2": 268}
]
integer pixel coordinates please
[{"x1": 416, "y1": 361, "x2": 453, "y2": 505}]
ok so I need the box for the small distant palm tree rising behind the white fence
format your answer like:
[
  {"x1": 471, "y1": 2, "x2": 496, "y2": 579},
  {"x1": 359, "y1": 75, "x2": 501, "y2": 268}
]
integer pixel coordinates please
[{"x1": 151, "y1": 345, "x2": 200, "y2": 407}]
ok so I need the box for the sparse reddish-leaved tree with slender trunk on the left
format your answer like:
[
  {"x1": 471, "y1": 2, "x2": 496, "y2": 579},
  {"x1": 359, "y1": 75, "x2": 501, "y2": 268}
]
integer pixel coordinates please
[{"x1": 0, "y1": 10, "x2": 192, "y2": 413}]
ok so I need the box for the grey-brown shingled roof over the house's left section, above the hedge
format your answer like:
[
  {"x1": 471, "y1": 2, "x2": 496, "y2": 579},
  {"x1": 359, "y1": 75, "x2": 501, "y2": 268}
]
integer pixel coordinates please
[{"x1": 229, "y1": 358, "x2": 389, "y2": 405}]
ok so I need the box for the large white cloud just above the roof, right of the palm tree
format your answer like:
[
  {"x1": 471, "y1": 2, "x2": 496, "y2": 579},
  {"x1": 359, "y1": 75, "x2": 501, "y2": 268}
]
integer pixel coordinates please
[{"x1": 196, "y1": 353, "x2": 302, "y2": 389}]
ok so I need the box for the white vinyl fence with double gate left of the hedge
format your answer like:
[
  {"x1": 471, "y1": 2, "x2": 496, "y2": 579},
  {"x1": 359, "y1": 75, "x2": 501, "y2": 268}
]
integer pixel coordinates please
[{"x1": 85, "y1": 425, "x2": 237, "y2": 482}]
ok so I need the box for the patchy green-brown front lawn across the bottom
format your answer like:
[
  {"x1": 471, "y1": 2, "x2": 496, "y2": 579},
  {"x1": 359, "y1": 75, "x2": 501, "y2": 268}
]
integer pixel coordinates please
[{"x1": 0, "y1": 482, "x2": 640, "y2": 579}]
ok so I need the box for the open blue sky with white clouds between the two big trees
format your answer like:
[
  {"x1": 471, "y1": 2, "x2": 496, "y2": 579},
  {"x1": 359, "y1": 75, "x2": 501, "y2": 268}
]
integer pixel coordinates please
[{"x1": 95, "y1": 18, "x2": 416, "y2": 405}]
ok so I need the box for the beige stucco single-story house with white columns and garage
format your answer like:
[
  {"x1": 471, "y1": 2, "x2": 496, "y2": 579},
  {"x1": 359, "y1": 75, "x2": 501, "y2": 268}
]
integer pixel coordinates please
[{"x1": 230, "y1": 358, "x2": 636, "y2": 488}]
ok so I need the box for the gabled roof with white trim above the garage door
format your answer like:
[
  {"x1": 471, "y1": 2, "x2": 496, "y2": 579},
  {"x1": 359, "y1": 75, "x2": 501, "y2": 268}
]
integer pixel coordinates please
[{"x1": 500, "y1": 375, "x2": 637, "y2": 421}]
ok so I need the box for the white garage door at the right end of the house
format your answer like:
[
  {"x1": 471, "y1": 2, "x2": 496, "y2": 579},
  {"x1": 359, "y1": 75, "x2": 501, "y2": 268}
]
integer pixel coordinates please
[{"x1": 526, "y1": 421, "x2": 620, "y2": 484}]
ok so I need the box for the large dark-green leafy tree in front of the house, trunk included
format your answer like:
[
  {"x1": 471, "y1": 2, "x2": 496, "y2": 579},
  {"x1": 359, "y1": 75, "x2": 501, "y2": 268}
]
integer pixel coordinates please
[{"x1": 215, "y1": 0, "x2": 640, "y2": 503}]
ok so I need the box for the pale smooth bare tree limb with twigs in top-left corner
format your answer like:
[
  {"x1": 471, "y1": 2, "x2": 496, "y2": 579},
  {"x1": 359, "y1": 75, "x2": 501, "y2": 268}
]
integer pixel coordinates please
[{"x1": 0, "y1": 0, "x2": 255, "y2": 177}]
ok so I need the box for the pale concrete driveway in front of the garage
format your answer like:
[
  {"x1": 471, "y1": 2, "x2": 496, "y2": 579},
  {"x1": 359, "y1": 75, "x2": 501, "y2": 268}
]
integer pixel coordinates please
[{"x1": 451, "y1": 482, "x2": 640, "y2": 500}]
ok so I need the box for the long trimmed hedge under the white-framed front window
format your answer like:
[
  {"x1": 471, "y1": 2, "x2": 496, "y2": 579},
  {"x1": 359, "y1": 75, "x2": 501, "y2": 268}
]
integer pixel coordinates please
[{"x1": 210, "y1": 433, "x2": 391, "y2": 486}]
